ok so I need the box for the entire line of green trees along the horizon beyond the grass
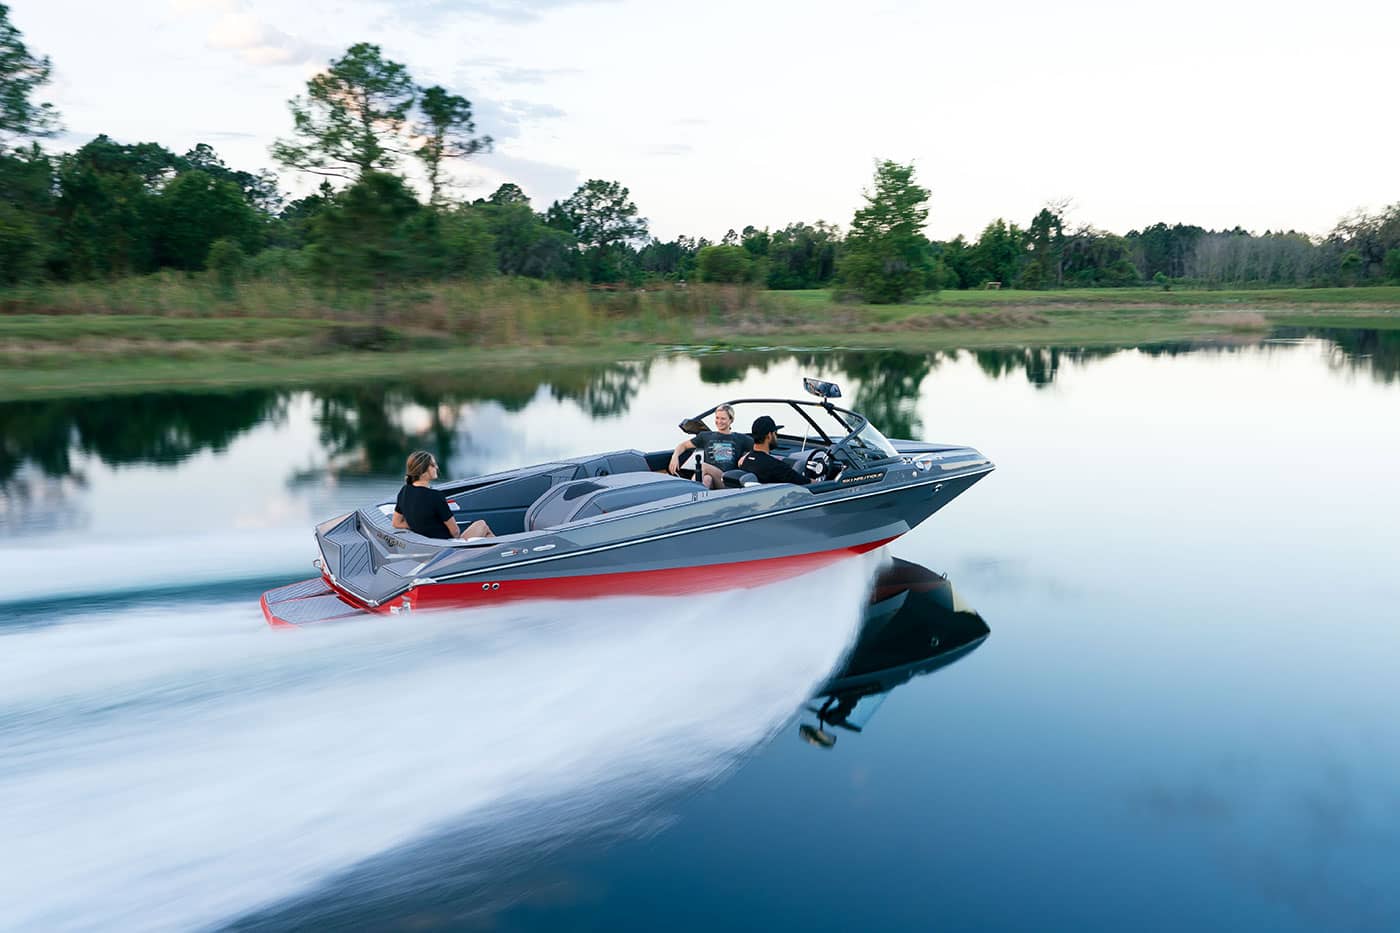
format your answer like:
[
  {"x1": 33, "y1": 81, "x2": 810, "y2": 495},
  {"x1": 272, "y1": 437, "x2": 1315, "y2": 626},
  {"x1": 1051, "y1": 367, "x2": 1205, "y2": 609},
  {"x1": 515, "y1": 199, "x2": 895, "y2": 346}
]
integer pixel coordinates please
[{"x1": 0, "y1": 4, "x2": 1400, "y2": 301}]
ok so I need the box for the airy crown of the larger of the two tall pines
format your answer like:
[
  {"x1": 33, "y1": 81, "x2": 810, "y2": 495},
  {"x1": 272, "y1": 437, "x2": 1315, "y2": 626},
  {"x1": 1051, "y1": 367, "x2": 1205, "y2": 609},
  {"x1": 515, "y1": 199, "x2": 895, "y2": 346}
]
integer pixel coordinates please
[{"x1": 272, "y1": 42, "x2": 417, "y2": 178}]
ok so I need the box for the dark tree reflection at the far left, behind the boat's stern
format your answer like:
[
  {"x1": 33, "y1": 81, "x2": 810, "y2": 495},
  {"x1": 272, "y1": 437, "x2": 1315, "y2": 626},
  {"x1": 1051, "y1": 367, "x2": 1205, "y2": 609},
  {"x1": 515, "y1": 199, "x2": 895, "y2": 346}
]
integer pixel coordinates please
[{"x1": 0, "y1": 389, "x2": 286, "y2": 485}]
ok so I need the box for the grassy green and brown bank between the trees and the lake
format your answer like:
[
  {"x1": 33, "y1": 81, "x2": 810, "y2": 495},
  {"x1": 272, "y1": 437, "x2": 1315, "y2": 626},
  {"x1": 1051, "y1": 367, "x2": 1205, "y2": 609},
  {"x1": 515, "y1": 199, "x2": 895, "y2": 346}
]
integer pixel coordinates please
[{"x1": 0, "y1": 275, "x2": 1400, "y2": 399}]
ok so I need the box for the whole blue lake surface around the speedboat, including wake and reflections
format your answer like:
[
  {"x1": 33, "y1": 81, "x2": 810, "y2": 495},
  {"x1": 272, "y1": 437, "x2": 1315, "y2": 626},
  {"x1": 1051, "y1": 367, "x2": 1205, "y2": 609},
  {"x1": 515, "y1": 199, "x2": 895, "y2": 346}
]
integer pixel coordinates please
[{"x1": 0, "y1": 331, "x2": 1400, "y2": 930}]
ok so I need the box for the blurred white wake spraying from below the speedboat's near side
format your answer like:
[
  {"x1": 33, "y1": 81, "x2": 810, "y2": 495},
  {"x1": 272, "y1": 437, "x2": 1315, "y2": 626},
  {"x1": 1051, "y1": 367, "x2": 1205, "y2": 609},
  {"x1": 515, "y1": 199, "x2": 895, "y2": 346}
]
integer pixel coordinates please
[{"x1": 0, "y1": 556, "x2": 876, "y2": 930}]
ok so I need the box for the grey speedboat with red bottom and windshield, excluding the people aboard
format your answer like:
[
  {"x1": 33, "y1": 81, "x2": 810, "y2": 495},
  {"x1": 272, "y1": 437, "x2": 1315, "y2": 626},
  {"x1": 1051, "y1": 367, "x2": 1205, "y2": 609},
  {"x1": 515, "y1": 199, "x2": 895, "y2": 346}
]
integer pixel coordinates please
[{"x1": 262, "y1": 378, "x2": 993, "y2": 626}]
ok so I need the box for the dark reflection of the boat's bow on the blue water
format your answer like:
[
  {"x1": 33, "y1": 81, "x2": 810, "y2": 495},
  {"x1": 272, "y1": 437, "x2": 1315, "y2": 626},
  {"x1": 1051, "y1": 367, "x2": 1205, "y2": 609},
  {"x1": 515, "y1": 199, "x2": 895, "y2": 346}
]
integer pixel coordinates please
[{"x1": 798, "y1": 558, "x2": 991, "y2": 748}]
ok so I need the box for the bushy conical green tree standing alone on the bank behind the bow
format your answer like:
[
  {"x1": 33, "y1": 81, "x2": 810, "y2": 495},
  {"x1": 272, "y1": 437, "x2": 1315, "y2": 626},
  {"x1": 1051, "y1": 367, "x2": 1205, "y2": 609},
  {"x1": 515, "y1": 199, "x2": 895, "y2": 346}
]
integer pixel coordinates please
[{"x1": 837, "y1": 160, "x2": 930, "y2": 304}]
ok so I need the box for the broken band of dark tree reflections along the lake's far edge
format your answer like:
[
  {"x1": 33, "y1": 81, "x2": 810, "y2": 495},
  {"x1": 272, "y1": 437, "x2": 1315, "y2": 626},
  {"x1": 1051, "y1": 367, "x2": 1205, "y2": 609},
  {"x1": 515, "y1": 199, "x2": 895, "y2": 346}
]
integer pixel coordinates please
[{"x1": 8, "y1": 328, "x2": 1400, "y2": 487}]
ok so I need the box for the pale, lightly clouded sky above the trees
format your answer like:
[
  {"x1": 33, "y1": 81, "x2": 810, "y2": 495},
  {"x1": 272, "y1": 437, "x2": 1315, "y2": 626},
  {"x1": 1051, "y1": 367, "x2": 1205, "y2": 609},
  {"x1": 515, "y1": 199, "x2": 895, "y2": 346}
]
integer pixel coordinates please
[{"x1": 8, "y1": 0, "x2": 1400, "y2": 240}]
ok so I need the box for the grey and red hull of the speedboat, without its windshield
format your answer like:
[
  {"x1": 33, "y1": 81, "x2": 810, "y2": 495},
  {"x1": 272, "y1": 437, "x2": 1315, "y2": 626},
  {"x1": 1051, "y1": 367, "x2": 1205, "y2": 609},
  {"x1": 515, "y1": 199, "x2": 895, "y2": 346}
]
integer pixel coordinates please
[{"x1": 263, "y1": 437, "x2": 993, "y2": 625}]
